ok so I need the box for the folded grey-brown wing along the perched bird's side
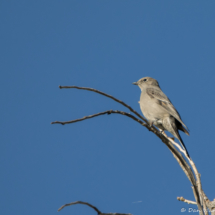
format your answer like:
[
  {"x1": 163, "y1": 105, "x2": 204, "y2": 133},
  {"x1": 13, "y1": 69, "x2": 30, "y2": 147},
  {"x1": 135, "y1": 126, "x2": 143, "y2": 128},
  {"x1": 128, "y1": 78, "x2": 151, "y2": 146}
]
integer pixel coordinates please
[{"x1": 146, "y1": 88, "x2": 188, "y2": 129}]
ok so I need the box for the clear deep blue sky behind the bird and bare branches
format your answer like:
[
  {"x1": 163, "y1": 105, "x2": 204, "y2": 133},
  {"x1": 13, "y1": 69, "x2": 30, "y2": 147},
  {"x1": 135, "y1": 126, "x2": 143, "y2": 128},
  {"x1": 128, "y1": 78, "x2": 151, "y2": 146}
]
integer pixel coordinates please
[{"x1": 0, "y1": 0, "x2": 215, "y2": 215}]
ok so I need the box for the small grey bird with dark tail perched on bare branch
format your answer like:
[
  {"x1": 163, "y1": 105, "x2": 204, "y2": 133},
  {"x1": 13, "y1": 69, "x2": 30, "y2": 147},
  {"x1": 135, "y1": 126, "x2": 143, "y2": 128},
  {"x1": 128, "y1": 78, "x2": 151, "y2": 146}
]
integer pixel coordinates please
[{"x1": 133, "y1": 77, "x2": 190, "y2": 157}]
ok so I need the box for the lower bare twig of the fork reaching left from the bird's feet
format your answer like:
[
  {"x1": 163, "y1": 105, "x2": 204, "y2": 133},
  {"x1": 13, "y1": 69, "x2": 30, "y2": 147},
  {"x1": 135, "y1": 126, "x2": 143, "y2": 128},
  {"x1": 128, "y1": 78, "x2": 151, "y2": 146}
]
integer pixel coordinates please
[{"x1": 51, "y1": 110, "x2": 146, "y2": 126}]
